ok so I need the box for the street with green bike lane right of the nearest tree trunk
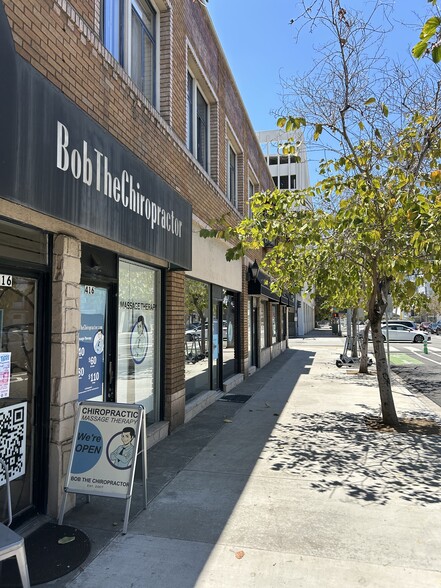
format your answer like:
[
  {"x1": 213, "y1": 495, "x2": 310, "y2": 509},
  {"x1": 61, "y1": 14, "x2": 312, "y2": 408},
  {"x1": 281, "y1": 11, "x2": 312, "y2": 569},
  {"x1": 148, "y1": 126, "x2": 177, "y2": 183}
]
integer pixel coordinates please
[{"x1": 389, "y1": 335, "x2": 441, "y2": 406}]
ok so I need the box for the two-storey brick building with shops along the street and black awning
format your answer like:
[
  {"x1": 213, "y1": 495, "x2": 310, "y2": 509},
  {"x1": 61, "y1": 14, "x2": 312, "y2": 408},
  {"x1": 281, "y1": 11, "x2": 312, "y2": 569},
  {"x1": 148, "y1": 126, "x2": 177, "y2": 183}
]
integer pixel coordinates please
[{"x1": 0, "y1": 0, "x2": 287, "y2": 520}]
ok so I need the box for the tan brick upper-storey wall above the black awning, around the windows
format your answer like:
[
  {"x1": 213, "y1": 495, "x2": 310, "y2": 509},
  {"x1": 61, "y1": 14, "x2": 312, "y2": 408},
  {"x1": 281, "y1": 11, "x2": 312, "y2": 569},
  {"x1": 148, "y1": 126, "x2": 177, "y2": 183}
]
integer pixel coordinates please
[{"x1": 5, "y1": 0, "x2": 270, "y2": 230}]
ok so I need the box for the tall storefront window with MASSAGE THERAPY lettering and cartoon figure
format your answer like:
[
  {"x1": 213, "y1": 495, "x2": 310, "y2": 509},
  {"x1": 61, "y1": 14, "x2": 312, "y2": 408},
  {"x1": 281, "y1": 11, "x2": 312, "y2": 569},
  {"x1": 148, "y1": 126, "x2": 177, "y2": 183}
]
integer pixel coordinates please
[{"x1": 116, "y1": 260, "x2": 160, "y2": 424}]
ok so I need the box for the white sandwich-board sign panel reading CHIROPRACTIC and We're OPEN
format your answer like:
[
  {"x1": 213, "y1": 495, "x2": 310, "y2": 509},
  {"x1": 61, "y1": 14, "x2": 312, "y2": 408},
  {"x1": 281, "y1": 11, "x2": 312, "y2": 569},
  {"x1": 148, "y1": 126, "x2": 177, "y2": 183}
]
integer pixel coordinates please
[{"x1": 65, "y1": 402, "x2": 143, "y2": 498}]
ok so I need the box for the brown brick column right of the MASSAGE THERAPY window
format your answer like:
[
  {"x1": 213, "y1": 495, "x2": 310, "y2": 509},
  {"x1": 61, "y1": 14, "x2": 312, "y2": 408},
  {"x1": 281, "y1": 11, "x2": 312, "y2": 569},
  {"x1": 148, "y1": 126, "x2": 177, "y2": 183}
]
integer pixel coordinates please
[{"x1": 164, "y1": 272, "x2": 185, "y2": 431}]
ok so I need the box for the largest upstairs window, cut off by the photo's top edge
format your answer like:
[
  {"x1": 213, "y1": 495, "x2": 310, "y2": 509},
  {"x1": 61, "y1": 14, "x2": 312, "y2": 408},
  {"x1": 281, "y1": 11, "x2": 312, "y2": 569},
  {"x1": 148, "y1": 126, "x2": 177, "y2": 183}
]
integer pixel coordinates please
[{"x1": 102, "y1": 0, "x2": 157, "y2": 104}]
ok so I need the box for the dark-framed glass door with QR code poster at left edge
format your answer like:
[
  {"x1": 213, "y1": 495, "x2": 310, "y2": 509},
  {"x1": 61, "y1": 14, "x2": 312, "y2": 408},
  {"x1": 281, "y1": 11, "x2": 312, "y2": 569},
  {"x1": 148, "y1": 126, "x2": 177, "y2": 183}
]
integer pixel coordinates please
[{"x1": 0, "y1": 268, "x2": 50, "y2": 520}]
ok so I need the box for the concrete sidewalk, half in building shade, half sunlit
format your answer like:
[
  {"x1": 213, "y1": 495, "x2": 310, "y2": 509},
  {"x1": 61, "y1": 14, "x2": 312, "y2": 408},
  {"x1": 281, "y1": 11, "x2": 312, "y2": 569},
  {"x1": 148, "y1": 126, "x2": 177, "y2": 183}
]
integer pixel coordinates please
[{"x1": 52, "y1": 330, "x2": 441, "y2": 588}]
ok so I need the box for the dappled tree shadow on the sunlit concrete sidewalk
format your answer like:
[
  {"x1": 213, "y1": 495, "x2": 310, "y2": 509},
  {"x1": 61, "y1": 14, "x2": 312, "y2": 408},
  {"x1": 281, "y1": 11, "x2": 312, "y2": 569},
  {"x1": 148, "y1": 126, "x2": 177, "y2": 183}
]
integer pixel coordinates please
[{"x1": 262, "y1": 412, "x2": 441, "y2": 506}]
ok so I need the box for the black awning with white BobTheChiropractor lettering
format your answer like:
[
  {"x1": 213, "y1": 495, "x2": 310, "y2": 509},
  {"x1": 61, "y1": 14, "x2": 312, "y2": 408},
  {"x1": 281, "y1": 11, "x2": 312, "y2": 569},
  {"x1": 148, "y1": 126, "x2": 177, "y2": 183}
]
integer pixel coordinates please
[{"x1": 0, "y1": 0, "x2": 192, "y2": 269}]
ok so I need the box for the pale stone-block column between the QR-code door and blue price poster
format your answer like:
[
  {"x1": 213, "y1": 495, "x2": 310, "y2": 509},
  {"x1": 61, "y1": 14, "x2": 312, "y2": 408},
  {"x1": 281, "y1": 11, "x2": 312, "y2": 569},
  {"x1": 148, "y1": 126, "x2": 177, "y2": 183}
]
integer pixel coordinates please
[{"x1": 48, "y1": 235, "x2": 81, "y2": 517}]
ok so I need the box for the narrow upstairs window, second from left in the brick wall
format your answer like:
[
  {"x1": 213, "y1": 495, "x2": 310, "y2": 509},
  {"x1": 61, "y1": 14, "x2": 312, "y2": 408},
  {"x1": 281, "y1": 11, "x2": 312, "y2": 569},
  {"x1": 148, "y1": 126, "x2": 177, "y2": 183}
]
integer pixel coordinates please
[{"x1": 187, "y1": 73, "x2": 208, "y2": 171}]
